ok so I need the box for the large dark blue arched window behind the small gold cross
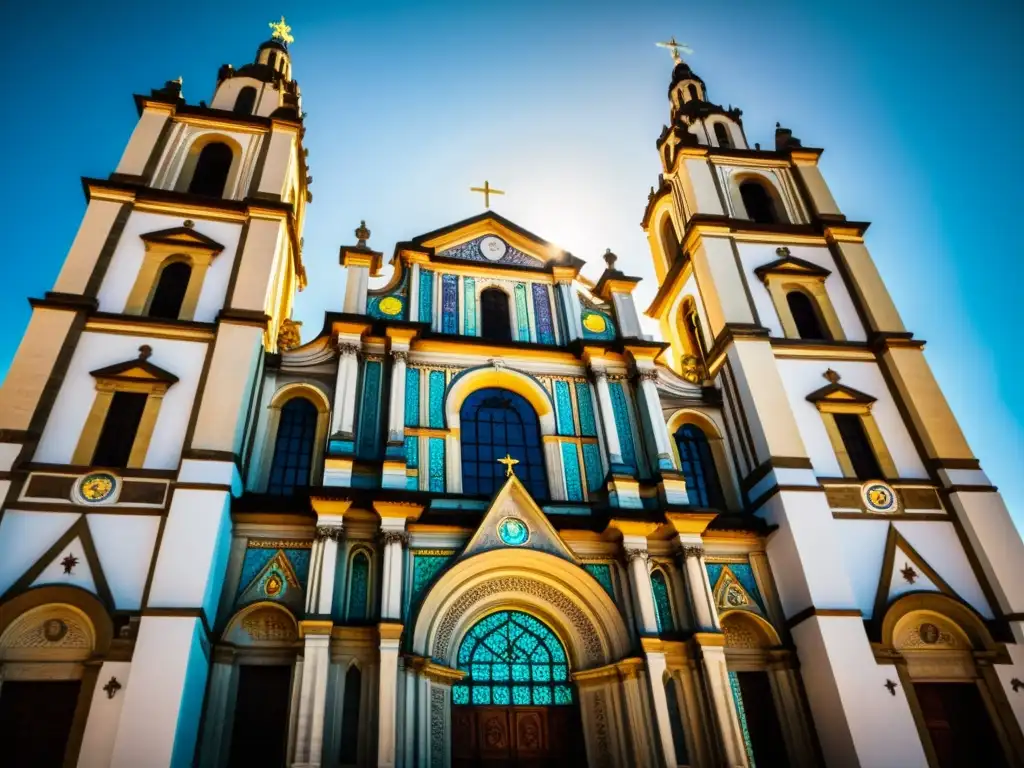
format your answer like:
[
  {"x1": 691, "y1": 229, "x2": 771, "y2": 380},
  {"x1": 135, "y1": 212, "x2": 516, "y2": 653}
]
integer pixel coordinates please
[{"x1": 459, "y1": 388, "x2": 548, "y2": 500}]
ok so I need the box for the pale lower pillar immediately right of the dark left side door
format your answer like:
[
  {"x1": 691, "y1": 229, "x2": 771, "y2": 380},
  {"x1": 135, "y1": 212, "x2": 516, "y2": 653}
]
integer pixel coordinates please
[{"x1": 292, "y1": 621, "x2": 334, "y2": 768}]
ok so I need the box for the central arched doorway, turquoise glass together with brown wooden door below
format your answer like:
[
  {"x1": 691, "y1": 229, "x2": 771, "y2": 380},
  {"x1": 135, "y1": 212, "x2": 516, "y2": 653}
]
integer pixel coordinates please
[{"x1": 452, "y1": 610, "x2": 585, "y2": 768}]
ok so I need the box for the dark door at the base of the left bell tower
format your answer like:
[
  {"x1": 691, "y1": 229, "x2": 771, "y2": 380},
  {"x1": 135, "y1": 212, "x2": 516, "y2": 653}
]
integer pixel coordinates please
[{"x1": 0, "y1": 680, "x2": 82, "y2": 768}]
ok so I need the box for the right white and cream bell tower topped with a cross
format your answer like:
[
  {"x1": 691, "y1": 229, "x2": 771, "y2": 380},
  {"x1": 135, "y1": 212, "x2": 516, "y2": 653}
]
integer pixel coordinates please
[{"x1": 642, "y1": 40, "x2": 1024, "y2": 765}]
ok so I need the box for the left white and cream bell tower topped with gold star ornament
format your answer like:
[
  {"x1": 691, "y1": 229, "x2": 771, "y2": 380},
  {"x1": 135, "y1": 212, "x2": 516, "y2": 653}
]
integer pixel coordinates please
[{"x1": 0, "y1": 18, "x2": 311, "y2": 766}]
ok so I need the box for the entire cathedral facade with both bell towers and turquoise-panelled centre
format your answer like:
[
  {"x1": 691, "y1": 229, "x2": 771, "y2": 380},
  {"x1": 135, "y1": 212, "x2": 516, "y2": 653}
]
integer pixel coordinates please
[{"x1": 0, "y1": 19, "x2": 1024, "y2": 768}]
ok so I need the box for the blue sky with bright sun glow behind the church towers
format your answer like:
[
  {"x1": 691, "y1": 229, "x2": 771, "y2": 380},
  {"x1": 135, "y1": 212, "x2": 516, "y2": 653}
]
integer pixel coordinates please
[{"x1": 0, "y1": 0, "x2": 1024, "y2": 525}]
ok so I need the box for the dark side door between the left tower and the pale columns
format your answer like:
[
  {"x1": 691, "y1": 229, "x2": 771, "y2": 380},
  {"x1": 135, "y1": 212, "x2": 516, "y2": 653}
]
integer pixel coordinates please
[{"x1": 227, "y1": 665, "x2": 292, "y2": 768}]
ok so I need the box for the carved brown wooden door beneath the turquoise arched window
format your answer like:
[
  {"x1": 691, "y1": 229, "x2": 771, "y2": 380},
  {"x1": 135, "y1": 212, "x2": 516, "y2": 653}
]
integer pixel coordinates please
[{"x1": 452, "y1": 707, "x2": 586, "y2": 768}]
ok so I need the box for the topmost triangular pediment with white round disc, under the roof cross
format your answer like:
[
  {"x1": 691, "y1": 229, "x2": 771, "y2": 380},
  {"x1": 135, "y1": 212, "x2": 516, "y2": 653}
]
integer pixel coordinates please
[{"x1": 411, "y1": 211, "x2": 582, "y2": 269}]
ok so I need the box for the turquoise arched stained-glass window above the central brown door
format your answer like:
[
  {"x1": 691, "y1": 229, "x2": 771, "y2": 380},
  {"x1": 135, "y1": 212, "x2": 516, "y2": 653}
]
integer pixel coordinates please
[{"x1": 452, "y1": 610, "x2": 572, "y2": 707}]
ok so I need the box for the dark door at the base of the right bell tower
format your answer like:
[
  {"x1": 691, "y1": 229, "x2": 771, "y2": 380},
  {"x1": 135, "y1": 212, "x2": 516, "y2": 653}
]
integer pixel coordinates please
[{"x1": 913, "y1": 683, "x2": 1007, "y2": 768}]
